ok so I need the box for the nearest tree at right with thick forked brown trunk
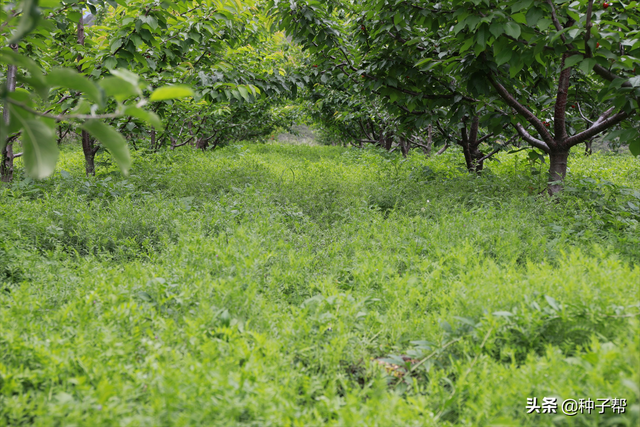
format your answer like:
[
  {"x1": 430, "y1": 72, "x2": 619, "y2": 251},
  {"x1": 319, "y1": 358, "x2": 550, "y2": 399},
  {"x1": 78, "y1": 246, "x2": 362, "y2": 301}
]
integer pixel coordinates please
[{"x1": 452, "y1": 0, "x2": 640, "y2": 194}]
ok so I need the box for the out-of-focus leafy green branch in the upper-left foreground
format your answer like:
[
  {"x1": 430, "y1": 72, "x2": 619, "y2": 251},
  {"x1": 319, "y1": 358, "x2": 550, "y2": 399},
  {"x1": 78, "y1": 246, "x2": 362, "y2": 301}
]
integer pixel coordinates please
[{"x1": 0, "y1": 0, "x2": 191, "y2": 180}]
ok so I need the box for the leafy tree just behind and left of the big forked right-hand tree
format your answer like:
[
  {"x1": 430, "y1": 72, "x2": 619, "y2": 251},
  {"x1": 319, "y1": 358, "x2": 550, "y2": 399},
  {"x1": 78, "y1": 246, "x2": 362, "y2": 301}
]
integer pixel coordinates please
[{"x1": 272, "y1": 1, "x2": 516, "y2": 167}]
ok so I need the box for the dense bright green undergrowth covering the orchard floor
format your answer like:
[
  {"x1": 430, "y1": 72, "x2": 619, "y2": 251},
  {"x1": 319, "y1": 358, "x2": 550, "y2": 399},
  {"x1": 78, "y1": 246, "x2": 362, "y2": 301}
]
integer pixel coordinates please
[{"x1": 0, "y1": 144, "x2": 640, "y2": 426}]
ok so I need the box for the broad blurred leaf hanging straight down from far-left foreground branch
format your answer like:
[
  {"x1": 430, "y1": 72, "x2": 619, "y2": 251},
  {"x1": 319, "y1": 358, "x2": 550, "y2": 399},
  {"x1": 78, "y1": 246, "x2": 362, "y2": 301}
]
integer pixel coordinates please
[{"x1": 17, "y1": 114, "x2": 59, "y2": 179}]
